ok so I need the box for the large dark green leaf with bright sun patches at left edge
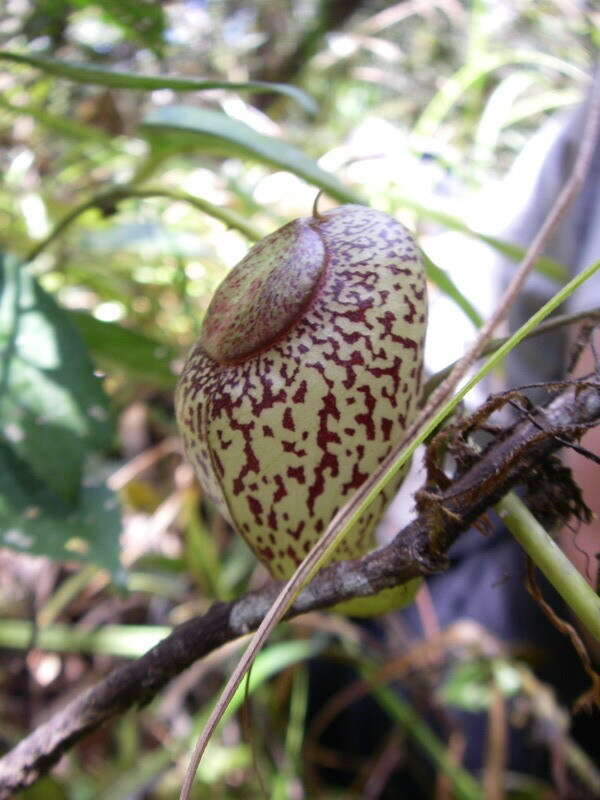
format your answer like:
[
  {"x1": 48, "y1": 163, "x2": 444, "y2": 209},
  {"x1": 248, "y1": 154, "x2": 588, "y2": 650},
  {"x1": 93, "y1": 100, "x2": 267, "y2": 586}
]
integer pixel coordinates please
[{"x1": 0, "y1": 253, "x2": 112, "y2": 502}]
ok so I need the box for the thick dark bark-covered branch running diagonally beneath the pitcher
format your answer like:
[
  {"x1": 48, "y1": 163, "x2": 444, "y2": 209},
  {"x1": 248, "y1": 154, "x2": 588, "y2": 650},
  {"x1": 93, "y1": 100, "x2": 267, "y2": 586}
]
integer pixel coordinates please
[{"x1": 0, "y1": 381, "x2": 600, "y2": 800}]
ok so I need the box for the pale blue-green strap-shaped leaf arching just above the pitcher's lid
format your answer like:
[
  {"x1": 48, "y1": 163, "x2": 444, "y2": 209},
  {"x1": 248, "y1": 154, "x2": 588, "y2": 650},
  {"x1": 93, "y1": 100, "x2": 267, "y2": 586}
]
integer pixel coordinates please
[{"x1": 141, "y1": 106, "x2": 363, "y2": 203}]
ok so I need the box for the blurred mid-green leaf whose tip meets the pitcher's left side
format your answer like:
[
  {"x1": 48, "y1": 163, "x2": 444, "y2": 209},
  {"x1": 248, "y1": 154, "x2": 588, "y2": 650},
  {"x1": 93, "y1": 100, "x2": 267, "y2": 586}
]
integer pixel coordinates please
[{"x1": 69, "y1": 311, "x2": 180, "y2": 389}]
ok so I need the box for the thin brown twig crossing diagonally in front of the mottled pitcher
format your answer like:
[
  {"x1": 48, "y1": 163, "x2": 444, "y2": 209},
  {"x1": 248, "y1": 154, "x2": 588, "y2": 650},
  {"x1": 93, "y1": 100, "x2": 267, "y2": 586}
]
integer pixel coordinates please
[{"x1": 180, "y1": 72, "x2": 600, "y2": 800}]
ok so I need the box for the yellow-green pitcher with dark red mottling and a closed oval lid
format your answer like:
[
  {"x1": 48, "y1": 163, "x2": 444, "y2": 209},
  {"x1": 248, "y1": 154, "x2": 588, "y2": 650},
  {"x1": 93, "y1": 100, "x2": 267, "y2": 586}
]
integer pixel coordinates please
[{"x1": 176, "y1": 206, "x2": 427, "y2": 578}]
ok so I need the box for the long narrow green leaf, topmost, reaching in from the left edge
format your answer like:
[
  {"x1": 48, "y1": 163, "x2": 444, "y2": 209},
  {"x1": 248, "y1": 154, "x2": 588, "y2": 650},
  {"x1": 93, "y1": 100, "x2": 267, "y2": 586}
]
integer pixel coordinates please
[{"x1": 0, "y1": 50, "x2": 317, "y2": 114}]
